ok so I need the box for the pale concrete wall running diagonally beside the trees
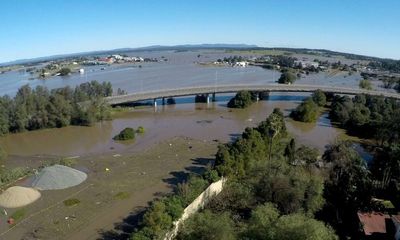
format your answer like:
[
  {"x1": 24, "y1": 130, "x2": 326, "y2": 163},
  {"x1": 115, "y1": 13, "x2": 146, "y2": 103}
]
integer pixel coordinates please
[{"x1": 164, "y1": 178, "x2": 226, "y2": 240}]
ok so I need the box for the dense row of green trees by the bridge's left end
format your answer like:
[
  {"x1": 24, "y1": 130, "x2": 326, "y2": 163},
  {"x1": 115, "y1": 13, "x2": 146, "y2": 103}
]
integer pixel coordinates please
[{"x1": 0, "y1": 81, "x2": 112, "y2": 135}]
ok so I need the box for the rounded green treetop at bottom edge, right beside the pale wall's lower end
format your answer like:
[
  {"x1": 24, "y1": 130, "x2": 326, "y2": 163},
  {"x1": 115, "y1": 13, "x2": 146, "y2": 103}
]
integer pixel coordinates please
[{"x1": 177, "y1": 210, "x2": 236, "y2": 240}]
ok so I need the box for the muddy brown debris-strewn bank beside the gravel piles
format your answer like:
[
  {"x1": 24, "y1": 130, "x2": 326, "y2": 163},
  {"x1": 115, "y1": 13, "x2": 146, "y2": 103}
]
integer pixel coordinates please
[{"x1": 0, "y1": 137, "x2": 217, "y2": 239}]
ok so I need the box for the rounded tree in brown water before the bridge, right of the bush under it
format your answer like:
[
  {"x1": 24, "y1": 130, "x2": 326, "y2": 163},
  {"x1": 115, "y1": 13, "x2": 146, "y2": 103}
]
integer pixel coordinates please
[{"x1": 290, "y1": 98, "x2": 320, "y2": 122}]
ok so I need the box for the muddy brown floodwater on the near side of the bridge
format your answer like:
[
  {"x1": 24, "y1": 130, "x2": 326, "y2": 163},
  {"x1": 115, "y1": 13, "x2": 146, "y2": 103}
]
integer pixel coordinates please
[{"x1": 0, "y1": 93, "x2": 344, "y2": 160}]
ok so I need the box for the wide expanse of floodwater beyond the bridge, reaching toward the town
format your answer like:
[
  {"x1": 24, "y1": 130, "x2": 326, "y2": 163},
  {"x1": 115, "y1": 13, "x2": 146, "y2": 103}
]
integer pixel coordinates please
[{"x1": 0, "y1": 51, "x2": 388, "y2": 96}]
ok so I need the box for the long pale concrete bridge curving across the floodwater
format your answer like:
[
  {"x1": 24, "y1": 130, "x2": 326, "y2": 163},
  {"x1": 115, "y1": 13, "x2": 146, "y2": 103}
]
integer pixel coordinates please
[{"x1": 105, "y1": 84, "x2": 400, "y2": 105}]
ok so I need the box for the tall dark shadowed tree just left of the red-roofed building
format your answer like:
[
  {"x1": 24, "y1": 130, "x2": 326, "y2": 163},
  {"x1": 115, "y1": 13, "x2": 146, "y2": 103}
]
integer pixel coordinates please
[{"x1": 321, "y1": 142, "x2": 372, "y2": 237}]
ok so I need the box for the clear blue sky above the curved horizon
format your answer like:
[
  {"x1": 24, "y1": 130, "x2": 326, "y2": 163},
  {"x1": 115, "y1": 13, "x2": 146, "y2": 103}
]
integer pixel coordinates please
[{"x1": 0, "y1": 0, "x2": 400, "y2": 62}]
